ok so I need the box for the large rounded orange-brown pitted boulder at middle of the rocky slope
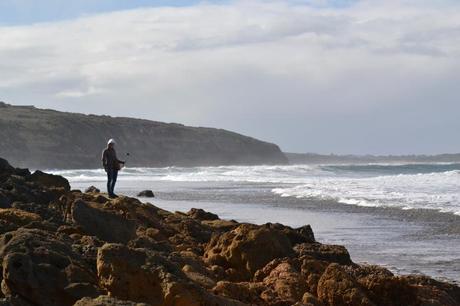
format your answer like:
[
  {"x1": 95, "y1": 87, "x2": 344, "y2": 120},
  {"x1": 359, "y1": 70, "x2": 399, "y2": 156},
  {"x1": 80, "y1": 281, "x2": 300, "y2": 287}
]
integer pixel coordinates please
[{"x1": 204, "y1": 224, "x2": 294, "y2": 281}]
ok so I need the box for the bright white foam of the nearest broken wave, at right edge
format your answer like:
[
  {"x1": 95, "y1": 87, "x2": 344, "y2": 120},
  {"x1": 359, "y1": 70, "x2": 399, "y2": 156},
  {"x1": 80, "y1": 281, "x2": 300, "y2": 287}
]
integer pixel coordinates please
[{"x1": 272, "y1": 170, "x2": 460, "y2": 215}]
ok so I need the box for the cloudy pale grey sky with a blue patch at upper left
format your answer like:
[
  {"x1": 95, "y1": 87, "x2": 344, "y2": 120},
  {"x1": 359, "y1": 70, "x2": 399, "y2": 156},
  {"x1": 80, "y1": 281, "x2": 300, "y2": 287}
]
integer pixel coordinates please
[{"x1": 0, "y1": 0, "x2": 460, "y2": 154}]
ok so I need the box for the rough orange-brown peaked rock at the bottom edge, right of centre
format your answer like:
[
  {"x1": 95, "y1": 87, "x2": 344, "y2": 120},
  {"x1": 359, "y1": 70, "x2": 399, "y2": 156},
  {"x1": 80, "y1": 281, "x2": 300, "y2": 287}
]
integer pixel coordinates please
[{"x1": 318, "y1": 263, "x2": 376, "y2": 306}]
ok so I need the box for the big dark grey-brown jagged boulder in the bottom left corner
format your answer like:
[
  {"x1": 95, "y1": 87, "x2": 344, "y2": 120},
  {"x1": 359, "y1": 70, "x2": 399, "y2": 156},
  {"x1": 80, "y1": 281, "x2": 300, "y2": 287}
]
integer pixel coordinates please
[{"x1": 0, "y1": 229, "x2": 102, "y2": 306}]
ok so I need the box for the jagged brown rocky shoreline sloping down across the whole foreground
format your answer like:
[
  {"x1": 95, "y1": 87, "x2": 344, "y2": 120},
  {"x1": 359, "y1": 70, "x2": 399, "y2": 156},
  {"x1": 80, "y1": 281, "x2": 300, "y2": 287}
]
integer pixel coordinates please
[{"x1": 0, "y1": 159, "x2": 460, "y2": 306}]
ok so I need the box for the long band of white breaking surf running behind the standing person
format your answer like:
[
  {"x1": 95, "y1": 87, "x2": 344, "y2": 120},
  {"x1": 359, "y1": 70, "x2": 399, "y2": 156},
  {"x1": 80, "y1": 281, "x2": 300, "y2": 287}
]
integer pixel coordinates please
[{"x1": 49, "y1": 164, "x2": 460, "y2": 215}]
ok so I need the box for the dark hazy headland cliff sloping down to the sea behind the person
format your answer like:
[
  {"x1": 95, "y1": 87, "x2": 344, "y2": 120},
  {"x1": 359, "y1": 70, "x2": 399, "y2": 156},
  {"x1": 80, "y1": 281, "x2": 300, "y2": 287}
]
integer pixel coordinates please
[{"x1": 0, "y1": 102, "x2": 287, "y2": 169}]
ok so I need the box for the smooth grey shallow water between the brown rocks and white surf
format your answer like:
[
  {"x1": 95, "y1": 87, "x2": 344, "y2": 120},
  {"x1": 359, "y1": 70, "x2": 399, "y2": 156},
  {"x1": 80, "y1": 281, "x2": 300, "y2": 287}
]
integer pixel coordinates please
[{"x1": 71, "y1": 181, "x2": 460, "y2": 283}]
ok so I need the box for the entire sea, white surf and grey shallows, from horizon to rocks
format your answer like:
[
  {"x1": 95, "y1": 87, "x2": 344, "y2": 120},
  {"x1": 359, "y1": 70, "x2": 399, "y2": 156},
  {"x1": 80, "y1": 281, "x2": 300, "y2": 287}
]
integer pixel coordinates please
[{"x1": 49, "y1": 163, "x2": 460, "y2": 282}]
